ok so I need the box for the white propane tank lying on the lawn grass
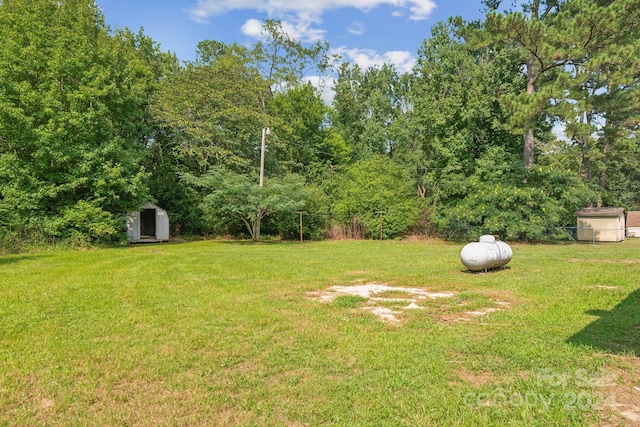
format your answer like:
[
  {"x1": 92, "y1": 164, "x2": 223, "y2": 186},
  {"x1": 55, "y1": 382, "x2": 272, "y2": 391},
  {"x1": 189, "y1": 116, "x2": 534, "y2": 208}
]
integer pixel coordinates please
[{"x1": 460, "y1": 235, "x2": 513, "y2": 271}]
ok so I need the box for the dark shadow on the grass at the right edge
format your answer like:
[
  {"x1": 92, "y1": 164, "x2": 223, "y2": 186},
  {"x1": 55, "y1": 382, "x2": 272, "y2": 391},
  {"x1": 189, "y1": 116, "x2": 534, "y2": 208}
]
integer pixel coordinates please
[{"x1": 567, "y1": 289, "x2": 640, "y2": 356}]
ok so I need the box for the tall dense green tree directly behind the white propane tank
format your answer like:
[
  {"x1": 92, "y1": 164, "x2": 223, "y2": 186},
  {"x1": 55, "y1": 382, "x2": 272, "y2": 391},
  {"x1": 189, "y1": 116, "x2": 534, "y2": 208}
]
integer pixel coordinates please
[{"x1": 410, "y1": 17, "x2": 597, "y2": 239}]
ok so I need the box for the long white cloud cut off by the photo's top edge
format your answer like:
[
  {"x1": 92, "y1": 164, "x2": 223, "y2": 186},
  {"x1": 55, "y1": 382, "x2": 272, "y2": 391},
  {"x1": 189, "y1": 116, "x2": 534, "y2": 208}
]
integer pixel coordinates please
[{"x1": 187, "y1": 0, "x2": 436, "y2": 22}]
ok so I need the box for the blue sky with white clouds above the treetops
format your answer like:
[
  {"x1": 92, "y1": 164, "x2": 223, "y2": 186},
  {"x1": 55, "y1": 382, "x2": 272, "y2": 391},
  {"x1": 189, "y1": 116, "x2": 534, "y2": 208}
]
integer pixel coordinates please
[{"x1": 97, "y1": 0, "x2": 483, "y2": 71}]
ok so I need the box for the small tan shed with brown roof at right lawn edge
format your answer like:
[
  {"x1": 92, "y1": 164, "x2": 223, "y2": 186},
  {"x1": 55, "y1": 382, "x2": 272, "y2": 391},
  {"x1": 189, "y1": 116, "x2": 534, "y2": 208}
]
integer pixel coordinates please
[{"x1": 576, "y1": 208, "x2": 625, "y2": 242}]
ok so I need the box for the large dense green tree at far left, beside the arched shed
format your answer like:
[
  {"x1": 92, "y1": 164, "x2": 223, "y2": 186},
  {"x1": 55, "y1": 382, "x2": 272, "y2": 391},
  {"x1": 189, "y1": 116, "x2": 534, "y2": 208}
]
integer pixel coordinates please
[{"x1": 0, "y1": 0, "x2": 154, "y2": 244}]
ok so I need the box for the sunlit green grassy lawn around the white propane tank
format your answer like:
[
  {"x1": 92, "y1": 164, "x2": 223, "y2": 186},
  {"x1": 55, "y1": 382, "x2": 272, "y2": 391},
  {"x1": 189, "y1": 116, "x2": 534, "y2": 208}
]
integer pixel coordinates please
[{"x1": 0, "y1": 241, "x2": 640, "y2": 426}]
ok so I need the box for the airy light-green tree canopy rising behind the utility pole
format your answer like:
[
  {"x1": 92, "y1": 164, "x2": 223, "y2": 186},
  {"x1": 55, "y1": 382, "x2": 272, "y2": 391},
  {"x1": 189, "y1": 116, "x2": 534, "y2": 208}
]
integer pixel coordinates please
[{"x1": 153, "y1": 20, "x2": 327, "y2": 174}]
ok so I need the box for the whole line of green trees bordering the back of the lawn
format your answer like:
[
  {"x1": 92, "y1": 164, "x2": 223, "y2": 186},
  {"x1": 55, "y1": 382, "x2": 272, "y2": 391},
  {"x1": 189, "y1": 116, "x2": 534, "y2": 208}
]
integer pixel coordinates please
[{"x1": 0, "y1": 0, "x2": 640, "y2": 250}]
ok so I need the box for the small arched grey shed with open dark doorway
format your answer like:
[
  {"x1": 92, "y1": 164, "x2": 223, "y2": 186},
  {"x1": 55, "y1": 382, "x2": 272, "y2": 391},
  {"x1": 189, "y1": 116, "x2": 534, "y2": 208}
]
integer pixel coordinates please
[{"x1": 127, "y1": 203, "x2": 169, "y2": 243}]
